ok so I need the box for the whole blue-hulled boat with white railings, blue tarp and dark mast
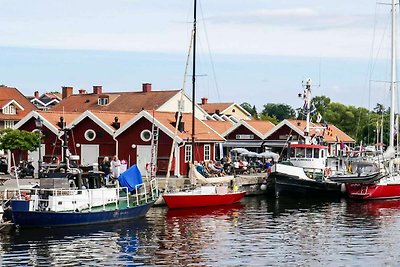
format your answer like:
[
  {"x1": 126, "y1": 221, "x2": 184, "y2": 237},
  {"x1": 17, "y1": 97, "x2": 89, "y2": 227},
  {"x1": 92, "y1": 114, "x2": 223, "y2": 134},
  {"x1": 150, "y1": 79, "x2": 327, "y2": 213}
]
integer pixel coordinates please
[{"x1": 10, "y1": 117, "x2": 158, "y2": 228}]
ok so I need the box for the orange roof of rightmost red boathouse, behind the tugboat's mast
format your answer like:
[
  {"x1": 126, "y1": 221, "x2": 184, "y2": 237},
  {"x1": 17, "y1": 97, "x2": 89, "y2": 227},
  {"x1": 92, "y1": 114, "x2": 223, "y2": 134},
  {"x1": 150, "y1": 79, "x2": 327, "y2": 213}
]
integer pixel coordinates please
[{"x1": 265, "y1": 120, "x2": 355, "y2": 143}]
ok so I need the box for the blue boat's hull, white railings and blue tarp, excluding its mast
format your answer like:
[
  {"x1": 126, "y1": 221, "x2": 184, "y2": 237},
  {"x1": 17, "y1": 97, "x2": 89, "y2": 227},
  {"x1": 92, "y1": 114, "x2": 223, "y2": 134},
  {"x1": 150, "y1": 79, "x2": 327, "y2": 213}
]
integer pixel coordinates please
[{"x1": 11, "y1": 165, "x2": 158, "y2": 227}]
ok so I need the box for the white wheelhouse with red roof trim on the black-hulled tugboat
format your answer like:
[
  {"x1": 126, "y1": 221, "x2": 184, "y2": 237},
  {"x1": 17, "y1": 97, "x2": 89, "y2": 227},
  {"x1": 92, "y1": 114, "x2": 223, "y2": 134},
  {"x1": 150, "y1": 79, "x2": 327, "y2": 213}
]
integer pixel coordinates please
[{"x1": 289, "y1": 144, "x2": 328, "y2": 169}]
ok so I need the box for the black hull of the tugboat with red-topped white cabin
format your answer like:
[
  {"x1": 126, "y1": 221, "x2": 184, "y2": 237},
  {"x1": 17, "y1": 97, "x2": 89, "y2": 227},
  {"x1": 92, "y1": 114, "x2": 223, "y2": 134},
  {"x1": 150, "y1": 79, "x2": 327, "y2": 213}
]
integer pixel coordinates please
[{"x1": 267, "y1": 172, "x2": 343, "y2": 198}]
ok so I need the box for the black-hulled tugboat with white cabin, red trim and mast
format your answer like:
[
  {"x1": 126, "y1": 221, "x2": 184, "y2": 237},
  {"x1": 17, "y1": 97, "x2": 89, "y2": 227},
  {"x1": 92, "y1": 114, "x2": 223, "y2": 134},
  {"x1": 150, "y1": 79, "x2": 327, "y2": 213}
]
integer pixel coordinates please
[{"x1": 267, "y1": 79, "x2": 343, "y2": 198}]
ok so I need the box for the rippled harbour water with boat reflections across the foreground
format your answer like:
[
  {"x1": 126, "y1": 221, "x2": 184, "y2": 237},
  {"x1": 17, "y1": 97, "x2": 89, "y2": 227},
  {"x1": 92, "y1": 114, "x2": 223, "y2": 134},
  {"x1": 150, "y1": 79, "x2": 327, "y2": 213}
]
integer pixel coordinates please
[{"x1": 0, "y1": 197, "x2": 400, "y2": 266}]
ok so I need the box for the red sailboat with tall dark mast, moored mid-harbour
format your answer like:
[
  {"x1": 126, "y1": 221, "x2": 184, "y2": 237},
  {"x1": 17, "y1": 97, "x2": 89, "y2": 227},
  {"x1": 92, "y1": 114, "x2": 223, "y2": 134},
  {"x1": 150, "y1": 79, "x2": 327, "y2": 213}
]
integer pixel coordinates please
[{"x1": 162, "y1": 0, "x2": 246, "y2": 209}]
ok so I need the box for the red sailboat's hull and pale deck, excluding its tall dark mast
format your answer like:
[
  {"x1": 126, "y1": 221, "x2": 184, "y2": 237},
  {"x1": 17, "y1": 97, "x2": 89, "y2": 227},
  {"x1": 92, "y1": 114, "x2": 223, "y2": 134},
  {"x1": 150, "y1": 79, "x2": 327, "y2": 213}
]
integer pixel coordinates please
[{"x1": 163, "y1": 186, "x2": 246, "y2": 209}]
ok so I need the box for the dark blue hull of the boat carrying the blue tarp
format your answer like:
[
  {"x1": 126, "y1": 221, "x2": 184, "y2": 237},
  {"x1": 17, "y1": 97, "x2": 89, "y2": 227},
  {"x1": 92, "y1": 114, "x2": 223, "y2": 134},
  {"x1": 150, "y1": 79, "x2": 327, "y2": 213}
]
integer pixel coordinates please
[{"x1": 11, "y1": 200, "x2": 153, "y2": 227}]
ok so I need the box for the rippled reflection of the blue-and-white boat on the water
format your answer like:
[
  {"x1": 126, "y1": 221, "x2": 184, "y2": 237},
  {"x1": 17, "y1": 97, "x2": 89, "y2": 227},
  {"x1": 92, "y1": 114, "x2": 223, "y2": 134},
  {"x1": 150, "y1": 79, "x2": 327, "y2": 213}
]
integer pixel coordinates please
[{"x1": 1, "y1": 220, "x2": 149, "y2": 266}]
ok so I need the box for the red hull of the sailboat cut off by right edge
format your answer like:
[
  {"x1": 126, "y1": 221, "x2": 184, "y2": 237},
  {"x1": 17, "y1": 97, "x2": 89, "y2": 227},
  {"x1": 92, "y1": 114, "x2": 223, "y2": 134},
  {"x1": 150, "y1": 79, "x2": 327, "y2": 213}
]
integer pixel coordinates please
[{"x1": 346, "y1": 183, "x2": 400, "y2": 200}]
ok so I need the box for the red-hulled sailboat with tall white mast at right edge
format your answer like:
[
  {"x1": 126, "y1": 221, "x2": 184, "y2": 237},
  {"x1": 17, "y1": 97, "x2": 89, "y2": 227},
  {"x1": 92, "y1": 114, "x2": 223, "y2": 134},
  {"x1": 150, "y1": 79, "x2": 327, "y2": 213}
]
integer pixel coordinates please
[{"x1": 345, "y1": 0, "x2": 400, "y2": 200}]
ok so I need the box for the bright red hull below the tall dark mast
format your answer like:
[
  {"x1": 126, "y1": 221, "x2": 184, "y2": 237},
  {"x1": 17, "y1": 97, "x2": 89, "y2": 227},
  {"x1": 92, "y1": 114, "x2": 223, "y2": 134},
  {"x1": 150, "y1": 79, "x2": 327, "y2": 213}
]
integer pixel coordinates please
[{"x1": 163, "y1": 192, "x2": 246, "y2": 209}]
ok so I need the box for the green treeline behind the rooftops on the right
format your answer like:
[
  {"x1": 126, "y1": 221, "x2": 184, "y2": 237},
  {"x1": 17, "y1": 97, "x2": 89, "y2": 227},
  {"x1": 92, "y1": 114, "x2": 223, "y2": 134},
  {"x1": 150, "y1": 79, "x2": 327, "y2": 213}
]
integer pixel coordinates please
[{"x1": 241, "y1": 96, "x2": 390, "y2": 144}]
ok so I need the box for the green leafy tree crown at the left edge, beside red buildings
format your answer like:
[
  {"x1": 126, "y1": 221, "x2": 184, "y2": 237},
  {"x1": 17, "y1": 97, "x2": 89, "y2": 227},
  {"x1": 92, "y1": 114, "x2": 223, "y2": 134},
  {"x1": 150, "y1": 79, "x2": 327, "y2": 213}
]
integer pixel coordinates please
[{"x1": 0, "y1": 129, "x2": 40, "y2": 151}]
